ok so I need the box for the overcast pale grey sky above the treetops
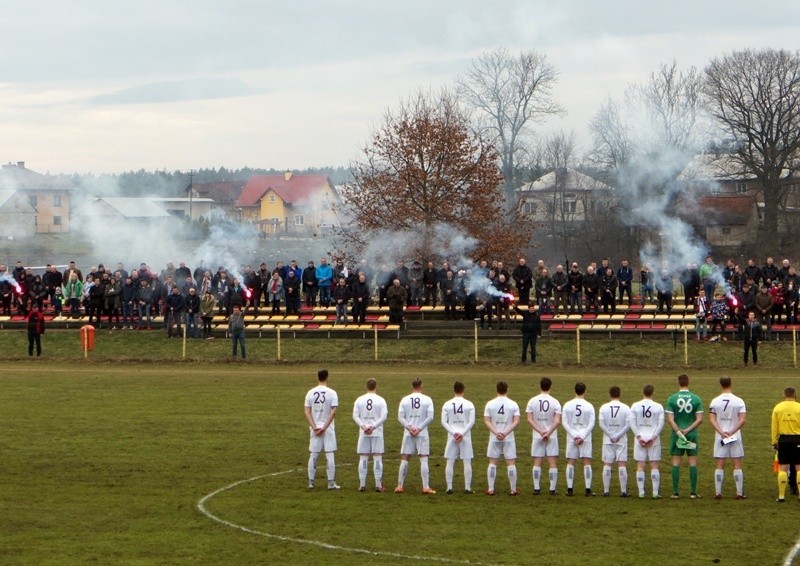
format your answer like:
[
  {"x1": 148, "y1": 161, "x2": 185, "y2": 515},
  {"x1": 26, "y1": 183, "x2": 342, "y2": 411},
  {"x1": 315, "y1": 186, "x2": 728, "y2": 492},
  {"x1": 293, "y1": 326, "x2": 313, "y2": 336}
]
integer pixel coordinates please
[{"x1": 0, "y1": 0, "x2": 800, "y2": 173}]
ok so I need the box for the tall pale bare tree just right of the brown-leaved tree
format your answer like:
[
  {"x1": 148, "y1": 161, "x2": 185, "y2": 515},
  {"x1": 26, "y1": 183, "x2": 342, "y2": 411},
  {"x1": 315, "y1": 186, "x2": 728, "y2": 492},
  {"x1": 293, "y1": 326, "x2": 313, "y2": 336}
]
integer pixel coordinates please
[{"x1": 457, "y1": 49, "x2": 563, "y2": 203}]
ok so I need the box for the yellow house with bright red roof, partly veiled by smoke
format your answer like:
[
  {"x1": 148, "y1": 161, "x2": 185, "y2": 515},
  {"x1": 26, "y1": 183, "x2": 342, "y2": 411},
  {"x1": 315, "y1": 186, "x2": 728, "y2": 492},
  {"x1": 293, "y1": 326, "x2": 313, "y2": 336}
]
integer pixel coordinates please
[{"x1": 236, "y1": 171, "x2": 339, "y2": 235}]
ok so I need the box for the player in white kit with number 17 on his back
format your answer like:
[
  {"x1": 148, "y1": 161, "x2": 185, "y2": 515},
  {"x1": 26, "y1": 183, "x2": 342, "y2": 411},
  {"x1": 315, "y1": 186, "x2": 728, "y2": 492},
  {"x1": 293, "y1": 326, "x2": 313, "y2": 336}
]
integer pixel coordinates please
[{"x1": 598, "y1": 385, "x2": 631, "y2": 497}]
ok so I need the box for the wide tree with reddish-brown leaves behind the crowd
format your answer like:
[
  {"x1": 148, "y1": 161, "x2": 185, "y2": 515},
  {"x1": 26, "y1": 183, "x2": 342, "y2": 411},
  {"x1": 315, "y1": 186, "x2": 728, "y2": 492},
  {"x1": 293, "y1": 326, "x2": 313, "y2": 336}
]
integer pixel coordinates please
[{"x1": 340, "y1": 91, "x2": 530, "y2": 258}]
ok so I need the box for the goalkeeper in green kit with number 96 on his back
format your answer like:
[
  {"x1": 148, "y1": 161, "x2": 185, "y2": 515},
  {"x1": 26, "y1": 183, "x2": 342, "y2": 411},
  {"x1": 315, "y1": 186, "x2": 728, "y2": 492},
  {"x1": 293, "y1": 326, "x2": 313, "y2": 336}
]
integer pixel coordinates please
[{"x1": 664, "y1": 373, "x2": 703, "y2": 499}]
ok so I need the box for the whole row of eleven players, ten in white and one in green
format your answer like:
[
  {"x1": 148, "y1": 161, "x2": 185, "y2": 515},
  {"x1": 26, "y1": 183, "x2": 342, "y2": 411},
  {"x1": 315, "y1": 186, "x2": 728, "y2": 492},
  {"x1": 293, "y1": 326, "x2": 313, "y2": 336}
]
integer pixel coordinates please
[{"x1": 305, "y1": 370, "x2": 746, "y2": 499}]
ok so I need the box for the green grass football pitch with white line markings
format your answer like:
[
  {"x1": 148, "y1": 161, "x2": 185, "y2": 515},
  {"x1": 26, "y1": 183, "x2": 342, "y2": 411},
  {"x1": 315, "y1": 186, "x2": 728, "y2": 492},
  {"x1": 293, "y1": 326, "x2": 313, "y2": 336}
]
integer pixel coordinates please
[{"x1": 0, "y1": 358, "x2": 800, "y2": 564}]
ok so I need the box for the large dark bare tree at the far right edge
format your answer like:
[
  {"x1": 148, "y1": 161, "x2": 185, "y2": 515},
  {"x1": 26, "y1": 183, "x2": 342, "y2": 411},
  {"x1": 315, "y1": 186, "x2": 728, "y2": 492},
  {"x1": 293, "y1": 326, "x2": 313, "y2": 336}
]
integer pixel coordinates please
[{"x1": 704, "y1": 49, "x2": 800, "y2": 251}]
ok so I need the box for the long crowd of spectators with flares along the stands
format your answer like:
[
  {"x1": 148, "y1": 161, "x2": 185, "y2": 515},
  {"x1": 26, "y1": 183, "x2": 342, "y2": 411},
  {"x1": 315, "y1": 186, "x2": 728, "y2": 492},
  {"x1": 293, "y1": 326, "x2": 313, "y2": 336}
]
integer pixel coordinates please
[{"x1": 0, "y1": 256, "x2": 800, "y2": 340}]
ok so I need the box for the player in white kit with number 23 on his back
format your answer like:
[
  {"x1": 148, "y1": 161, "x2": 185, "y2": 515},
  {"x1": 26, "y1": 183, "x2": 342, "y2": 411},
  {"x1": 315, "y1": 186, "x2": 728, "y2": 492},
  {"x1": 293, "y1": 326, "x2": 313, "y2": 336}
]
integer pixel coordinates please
[{"x1": 305, "y1": 369, "x2": 339, "y2": 490}]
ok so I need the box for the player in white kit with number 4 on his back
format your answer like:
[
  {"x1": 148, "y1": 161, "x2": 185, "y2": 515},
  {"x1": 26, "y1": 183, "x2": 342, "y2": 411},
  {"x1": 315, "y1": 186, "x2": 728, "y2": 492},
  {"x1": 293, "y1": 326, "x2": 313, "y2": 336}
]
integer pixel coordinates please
[{"x1": 483, "y1": 381, "x2": 519, "y2": 495}]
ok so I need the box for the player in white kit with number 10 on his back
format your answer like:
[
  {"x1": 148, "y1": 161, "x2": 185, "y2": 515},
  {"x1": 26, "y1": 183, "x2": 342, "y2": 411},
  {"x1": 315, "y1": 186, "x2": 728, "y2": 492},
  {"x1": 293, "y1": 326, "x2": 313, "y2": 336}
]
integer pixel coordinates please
[{"x1": 525, "y1": 377, "x2": 561, "y2": 495}]
